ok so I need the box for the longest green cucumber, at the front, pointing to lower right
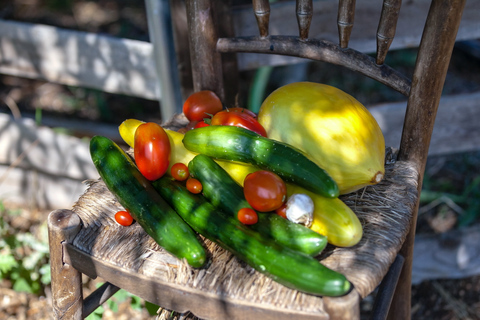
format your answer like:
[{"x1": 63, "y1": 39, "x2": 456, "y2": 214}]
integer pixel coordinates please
[{"x1": 153, "y1": 176, "x2": 351, "y2": 296}]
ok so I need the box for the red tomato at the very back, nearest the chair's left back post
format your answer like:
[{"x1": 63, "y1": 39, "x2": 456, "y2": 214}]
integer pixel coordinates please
[{"x1": 183, "y1": 90, "x2": 223, "y2": 121}]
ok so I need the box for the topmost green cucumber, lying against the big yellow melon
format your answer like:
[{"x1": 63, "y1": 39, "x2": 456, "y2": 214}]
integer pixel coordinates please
[{"x1": 183, "y1": 126, "x2": 339, "y2": 198}]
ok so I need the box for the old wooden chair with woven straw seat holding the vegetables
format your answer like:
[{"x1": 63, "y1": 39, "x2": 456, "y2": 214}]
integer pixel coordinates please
[{"x1": 48, "y1": 0, "x2": 465, "y2": 320}]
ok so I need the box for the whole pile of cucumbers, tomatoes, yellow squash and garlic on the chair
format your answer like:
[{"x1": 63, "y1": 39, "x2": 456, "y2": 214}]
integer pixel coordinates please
[{"x1": 90, "y1": 82, "x2": 385, "y2": 296}]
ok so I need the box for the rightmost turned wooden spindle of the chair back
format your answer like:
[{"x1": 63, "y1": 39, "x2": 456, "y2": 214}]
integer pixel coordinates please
[{"x1": 376, "y1": 0, "x2": 402, "y2": 65}]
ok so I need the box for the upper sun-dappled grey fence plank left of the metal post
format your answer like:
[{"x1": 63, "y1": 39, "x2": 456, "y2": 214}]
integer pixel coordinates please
[{"x1": 0, "y1": 20, "x2": 162, "y2": 100}]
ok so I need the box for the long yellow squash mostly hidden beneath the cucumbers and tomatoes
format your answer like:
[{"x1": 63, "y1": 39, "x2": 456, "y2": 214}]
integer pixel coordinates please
[{"x1": 119, "y1": 119, "x2": 363, "y2": 247}]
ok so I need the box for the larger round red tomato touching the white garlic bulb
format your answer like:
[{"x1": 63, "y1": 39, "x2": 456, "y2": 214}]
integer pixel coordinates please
[{"x1": 243, "y1": 170, "x2": 287, "y2": 212}]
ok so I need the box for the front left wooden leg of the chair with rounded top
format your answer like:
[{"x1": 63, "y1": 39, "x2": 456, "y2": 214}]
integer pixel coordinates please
[{"x1": 48, "y1": 210, "x2": 83, "y2": 320}]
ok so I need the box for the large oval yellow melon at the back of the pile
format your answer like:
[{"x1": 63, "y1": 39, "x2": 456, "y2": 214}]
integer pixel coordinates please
[{"x1": 258, "y1": 82, "x2": 385, "y2": 194}]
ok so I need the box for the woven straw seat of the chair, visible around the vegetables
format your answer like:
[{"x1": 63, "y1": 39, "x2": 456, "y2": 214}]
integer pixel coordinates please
[{"x1": 53, "y1": 154, "x2": 418, "y2": 319}]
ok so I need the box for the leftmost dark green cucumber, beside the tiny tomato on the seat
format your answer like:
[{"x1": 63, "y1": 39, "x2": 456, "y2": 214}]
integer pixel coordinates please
[{"x1": 90, "y1": 136, "x2": 207, "y2": 268}]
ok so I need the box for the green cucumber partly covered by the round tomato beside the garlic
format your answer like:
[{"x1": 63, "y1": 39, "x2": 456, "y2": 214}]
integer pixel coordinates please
[{"x1": 188, "y1": 154, "x2": 327, "y2": 256}]
